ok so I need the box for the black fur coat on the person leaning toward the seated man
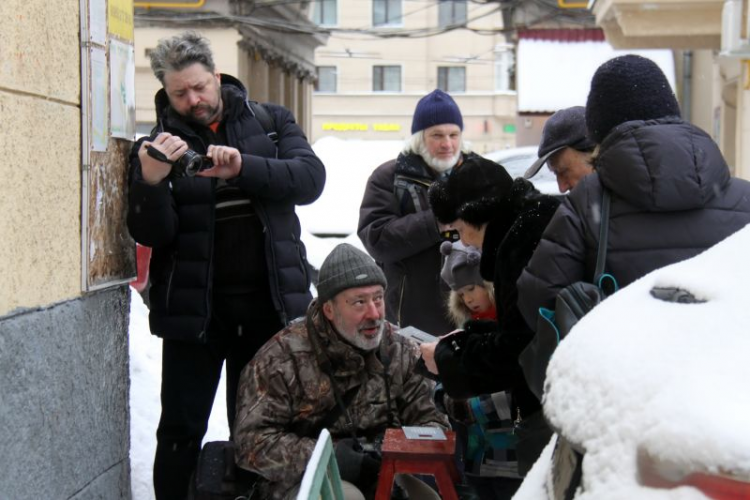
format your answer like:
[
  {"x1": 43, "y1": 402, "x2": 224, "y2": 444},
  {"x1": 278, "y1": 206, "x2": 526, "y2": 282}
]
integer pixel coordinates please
[{"x1": 435, "y1": 178, "x2": 560, "y2": 426}]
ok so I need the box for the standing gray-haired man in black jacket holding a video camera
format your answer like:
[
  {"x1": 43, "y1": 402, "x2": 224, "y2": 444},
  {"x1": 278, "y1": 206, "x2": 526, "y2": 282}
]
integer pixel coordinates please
[{"x1": 128, "y1": 32, "x2": 325, "y2": 500}]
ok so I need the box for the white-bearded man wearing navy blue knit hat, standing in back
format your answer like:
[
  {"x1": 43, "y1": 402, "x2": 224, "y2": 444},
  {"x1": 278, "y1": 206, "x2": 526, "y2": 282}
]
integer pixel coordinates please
[{"x1": 357, "y1": 89, "x2": 484, "y2": 335}]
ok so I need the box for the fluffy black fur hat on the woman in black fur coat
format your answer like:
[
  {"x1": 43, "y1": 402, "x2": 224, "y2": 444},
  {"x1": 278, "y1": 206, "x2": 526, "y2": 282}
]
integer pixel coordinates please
[{"x1": 429, "y1": 155, "x2": 513, "y2": 225}]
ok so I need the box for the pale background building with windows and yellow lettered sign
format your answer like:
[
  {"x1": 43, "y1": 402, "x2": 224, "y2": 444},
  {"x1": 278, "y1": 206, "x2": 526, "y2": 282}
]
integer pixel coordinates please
[{"x1": 311, "y1": 0, "x2": 516, "y2": 153}]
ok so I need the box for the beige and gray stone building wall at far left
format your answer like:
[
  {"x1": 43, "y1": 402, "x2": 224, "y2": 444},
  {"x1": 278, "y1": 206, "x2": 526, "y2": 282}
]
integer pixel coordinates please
[{"x1": 0, "y1": 0, "x2": 134, "y2": 499}]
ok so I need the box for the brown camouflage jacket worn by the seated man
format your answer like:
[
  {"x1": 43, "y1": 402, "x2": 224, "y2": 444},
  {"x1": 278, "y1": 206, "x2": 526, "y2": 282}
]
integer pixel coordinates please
[{"x1": 234, "y1": 302, "x2": 448, "y2": 499}]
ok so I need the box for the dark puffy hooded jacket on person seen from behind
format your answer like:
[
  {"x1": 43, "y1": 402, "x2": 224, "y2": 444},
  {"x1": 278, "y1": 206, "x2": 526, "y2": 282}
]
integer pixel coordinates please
[{"x1": 518, "y1": 118, "x2": 750, "y2": 328}]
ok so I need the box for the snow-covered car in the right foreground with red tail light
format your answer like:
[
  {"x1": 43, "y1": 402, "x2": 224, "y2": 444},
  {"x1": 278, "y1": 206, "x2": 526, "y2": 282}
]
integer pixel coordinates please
[{"x1": 514, "y1": 226, "x2": 750, "y2": 500}]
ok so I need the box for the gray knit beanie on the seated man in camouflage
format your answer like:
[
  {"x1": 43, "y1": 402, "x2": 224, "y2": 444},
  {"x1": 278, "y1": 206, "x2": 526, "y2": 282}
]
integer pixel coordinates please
[{"x1": 318, "y1": 243, "x2": 387, "y2": 303}]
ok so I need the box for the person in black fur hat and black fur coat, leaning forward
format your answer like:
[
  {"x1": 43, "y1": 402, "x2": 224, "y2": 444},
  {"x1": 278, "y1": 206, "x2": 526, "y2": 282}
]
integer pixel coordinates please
[{"x1": 421, "y1": 158, "x2": 560, "y2": 475}]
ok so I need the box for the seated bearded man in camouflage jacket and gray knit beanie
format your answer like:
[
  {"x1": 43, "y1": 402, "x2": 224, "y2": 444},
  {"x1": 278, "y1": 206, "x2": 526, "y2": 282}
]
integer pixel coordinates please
[{"x1": 234, "y1": 243, "x2": 448, "y2": 500}]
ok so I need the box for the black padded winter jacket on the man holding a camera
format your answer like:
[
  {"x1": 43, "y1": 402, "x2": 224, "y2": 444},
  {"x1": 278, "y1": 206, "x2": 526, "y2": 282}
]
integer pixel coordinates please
[{"x1": 128, "y1": 75, "x2": 325, "y2": 341}]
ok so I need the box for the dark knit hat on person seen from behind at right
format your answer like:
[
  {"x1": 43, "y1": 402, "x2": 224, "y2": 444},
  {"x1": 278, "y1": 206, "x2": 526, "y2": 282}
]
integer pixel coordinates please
[{"x1": 586, "y1": 54, "x2": 680, "y2": 143}]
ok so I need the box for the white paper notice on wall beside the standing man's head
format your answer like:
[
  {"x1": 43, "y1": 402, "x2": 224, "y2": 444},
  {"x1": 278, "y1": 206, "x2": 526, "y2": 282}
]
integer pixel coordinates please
[{"x1": 109, "y1": 40, "x2": 135, "y2": 141}]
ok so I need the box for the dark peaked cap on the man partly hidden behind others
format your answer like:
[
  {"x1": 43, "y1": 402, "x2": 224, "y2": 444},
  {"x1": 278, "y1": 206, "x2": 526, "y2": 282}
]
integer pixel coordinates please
[{"x1": 523, "y1": 106, "x2": 596, "y2": 179}]
